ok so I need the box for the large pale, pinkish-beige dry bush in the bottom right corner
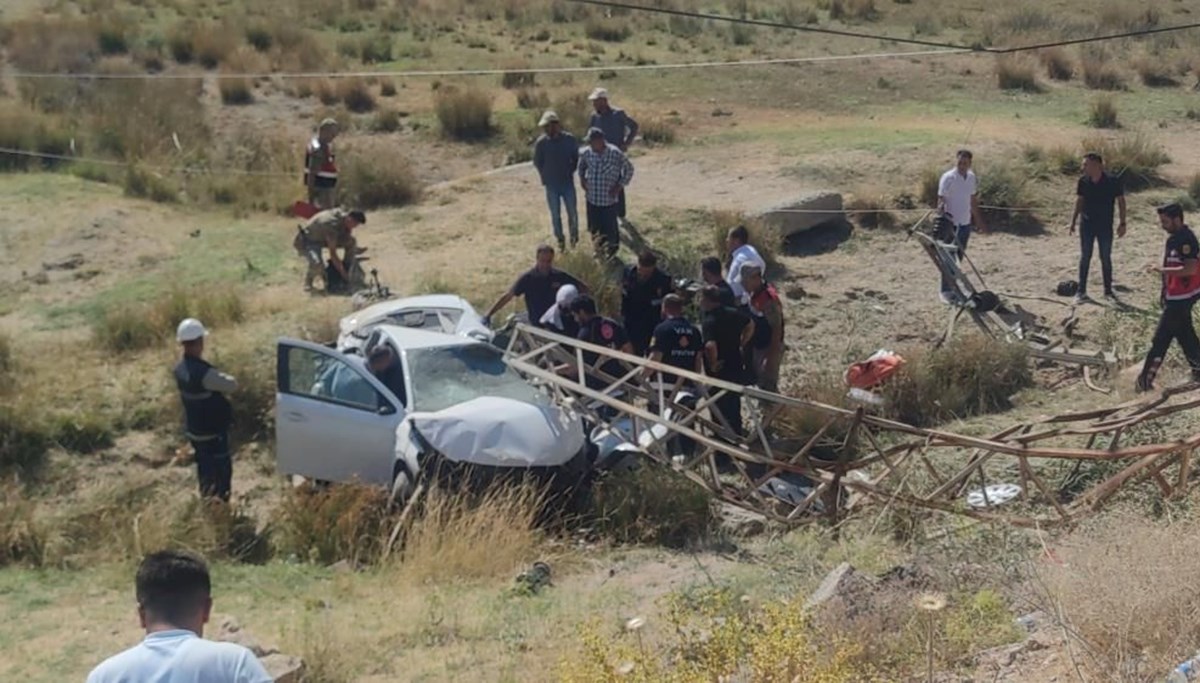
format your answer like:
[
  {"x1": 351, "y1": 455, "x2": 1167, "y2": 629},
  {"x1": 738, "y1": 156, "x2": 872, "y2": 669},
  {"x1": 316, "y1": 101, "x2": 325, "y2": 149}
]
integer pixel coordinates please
[{"x1": 1034, "y1": 514, "x2": 1200, "y2": 681}]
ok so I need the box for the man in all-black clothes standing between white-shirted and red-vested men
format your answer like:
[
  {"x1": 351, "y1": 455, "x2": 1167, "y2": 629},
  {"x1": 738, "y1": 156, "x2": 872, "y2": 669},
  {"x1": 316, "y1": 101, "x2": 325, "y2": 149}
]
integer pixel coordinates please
[{"x1": 1069, "y1": 152, "x2": 1126, "y2": 304}]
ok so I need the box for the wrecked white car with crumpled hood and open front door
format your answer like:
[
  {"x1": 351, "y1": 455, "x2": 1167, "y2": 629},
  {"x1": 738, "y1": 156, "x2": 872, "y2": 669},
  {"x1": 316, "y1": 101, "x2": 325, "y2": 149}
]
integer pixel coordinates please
[{"x1": 275, "y1": 322, "x2": 598, "y2": 501}]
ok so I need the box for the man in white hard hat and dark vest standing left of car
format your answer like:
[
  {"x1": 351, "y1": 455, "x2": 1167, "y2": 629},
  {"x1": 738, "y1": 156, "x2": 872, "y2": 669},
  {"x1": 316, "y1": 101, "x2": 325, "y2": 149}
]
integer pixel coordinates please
[{"x1": 175, "y1": 318, "x2": 238, "y2": 502}]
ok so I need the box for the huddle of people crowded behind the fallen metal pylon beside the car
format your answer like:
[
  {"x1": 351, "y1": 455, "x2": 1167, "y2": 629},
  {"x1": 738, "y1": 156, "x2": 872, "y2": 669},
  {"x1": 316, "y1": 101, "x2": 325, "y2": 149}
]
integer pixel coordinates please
[{"x1": 484, "y1": 226, "x2": 785, "y2": 433}]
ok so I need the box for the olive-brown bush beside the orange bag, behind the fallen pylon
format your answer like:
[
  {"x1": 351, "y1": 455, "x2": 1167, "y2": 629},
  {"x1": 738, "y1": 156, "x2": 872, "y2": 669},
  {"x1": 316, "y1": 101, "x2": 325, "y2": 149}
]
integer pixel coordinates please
[{"x1": 883, "y1": 335, "x2": 1033, "y2": 426}]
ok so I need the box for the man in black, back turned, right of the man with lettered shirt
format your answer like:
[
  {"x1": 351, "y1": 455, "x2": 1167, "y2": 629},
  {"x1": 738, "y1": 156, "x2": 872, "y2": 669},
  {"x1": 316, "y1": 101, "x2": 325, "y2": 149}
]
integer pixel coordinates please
[{"x1": 700, "y1": 286, "x2": 754, "y2": 436}]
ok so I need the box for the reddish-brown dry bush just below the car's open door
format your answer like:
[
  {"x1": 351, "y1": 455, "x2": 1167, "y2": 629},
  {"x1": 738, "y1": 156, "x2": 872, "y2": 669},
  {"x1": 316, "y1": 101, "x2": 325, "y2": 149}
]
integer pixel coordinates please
[{"x1": 272, "y1": 485, "x2": 396, "y2": 564}]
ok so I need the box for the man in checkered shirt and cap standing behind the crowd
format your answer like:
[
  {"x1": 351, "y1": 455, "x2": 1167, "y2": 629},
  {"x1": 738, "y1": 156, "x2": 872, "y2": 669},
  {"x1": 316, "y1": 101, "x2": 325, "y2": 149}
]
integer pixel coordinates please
[{"x1": 580, "y1": 128, "x2": 634, "y2": 258}]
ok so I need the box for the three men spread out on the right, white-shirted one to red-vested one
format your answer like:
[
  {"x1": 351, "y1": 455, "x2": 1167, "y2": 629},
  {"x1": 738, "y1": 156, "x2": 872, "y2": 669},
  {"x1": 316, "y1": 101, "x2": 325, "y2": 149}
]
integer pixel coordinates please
[{"x1": 937, "y1": 150, "x2": 1200, "y2": 391}]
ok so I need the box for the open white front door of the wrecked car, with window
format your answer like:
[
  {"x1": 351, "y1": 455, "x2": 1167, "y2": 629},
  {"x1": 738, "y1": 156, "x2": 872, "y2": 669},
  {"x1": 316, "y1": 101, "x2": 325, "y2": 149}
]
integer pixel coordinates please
[{"x1": 275, "y1": 338, "x2": 404, "y2": 486}]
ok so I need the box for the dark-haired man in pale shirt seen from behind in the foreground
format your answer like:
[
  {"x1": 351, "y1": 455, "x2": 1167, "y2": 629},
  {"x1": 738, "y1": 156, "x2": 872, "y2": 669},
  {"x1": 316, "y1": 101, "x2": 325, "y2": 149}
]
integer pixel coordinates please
[{"x1": 88, "y1": 550, "x2": 274, "y2": 683}]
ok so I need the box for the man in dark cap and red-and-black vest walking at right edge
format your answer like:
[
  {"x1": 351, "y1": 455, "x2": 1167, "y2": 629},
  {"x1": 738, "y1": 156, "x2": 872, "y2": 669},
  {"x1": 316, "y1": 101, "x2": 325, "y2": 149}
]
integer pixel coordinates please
[{"x1": 1136, "y1": 204, "x2": 1200, "y2": 391}]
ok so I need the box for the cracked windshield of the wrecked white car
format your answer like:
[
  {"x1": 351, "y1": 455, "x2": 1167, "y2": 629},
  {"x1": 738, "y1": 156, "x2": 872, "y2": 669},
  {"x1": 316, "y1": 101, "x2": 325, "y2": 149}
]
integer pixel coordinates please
[{"x1": 408, "y1": 343, "x2": 545, "y2": 413}]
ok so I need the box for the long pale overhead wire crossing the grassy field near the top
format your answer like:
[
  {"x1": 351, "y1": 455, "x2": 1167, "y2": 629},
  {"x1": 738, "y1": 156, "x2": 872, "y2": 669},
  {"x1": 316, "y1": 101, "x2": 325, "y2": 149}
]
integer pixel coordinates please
[{"x1": 8, "y1": 49, "x2": 970, "y2": 80}]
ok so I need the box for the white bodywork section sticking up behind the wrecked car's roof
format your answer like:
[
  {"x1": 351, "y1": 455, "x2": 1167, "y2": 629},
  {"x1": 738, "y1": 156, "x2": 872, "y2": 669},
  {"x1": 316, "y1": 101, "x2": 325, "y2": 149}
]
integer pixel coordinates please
[{"x1": 337, "y1": 294, "x2": 493, "y2": 353}]
